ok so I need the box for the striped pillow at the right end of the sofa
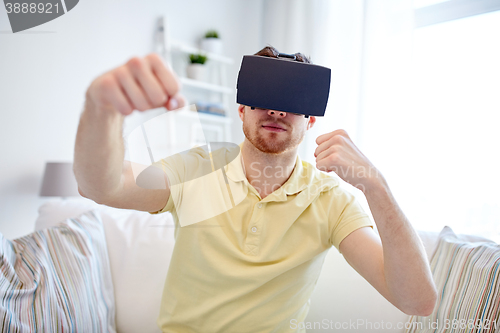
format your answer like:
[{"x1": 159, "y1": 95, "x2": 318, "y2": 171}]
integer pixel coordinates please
[{"x1": 406, "y1": 227, "x2": 500, "y2": 333}]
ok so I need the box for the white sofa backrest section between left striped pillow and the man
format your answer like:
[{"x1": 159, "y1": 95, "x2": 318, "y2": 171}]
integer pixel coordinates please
[{"x1": 35, "y1": 199, "x2": 174, "y2": 333}]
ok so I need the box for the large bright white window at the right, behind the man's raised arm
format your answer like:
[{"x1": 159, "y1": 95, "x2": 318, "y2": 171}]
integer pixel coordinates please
[{"x1": 406, "y1": 11, "x2": 500, "y2": 242}]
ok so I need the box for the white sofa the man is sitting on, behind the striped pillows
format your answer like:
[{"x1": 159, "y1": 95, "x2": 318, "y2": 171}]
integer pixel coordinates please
[{"x1": 35, "y1": 199, "x2": 448, "y2": 333}]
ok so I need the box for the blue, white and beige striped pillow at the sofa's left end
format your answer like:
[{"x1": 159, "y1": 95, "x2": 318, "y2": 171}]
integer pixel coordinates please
[{"x1": 0, "y1": 211, "x2": 115, "y2": 332}]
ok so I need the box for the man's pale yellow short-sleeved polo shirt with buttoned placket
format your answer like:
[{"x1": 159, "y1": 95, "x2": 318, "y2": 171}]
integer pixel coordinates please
[{"x1": 152, "y1": 144, "x2": 373, "y2": 333}]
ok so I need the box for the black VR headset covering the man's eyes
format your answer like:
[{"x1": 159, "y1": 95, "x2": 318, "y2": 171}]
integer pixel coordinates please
[{"x1": 236, "y1": 53, "x2": 331, "y2": 117}]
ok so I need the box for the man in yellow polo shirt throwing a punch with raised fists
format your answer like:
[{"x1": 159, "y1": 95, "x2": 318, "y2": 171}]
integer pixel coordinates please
[{"x1": 74, "y1": 47, "x2": 437, "y2": 332}]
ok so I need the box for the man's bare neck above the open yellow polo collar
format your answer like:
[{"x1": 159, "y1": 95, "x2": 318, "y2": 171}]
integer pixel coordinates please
[{"x1": 241, "y1": 138, "x2": 297, "y2": 199}]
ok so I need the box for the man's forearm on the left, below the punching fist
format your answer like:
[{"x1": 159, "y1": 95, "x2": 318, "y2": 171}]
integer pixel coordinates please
[{"x1": 73, "y1": 100, "x2": 124, "y2": 203}]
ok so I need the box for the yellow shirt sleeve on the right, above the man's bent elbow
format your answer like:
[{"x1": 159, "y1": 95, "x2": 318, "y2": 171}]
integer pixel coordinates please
[{"x1": 329, "y1": 187, "x2": 373, "y2": 253}]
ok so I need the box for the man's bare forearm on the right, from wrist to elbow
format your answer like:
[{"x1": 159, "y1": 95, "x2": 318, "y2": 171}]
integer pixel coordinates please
[{"x1": 365, "y1": 177, "x2": 436, "y2": 314}]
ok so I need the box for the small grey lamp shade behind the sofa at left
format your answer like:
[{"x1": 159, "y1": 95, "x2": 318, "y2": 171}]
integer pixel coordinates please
[{"x1": 40, "y1": 162, "x2": 80, "y2": 197}]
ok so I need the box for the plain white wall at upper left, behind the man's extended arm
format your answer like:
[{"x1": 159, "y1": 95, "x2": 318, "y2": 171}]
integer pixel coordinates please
[{"x1": 0, "y1": 0, "x2": 262, "y2": 238}]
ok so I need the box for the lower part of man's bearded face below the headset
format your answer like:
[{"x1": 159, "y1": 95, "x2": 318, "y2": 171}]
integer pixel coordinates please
[{"x1": 238, "y1": 105, "x2": 316, "y2": 154}]
